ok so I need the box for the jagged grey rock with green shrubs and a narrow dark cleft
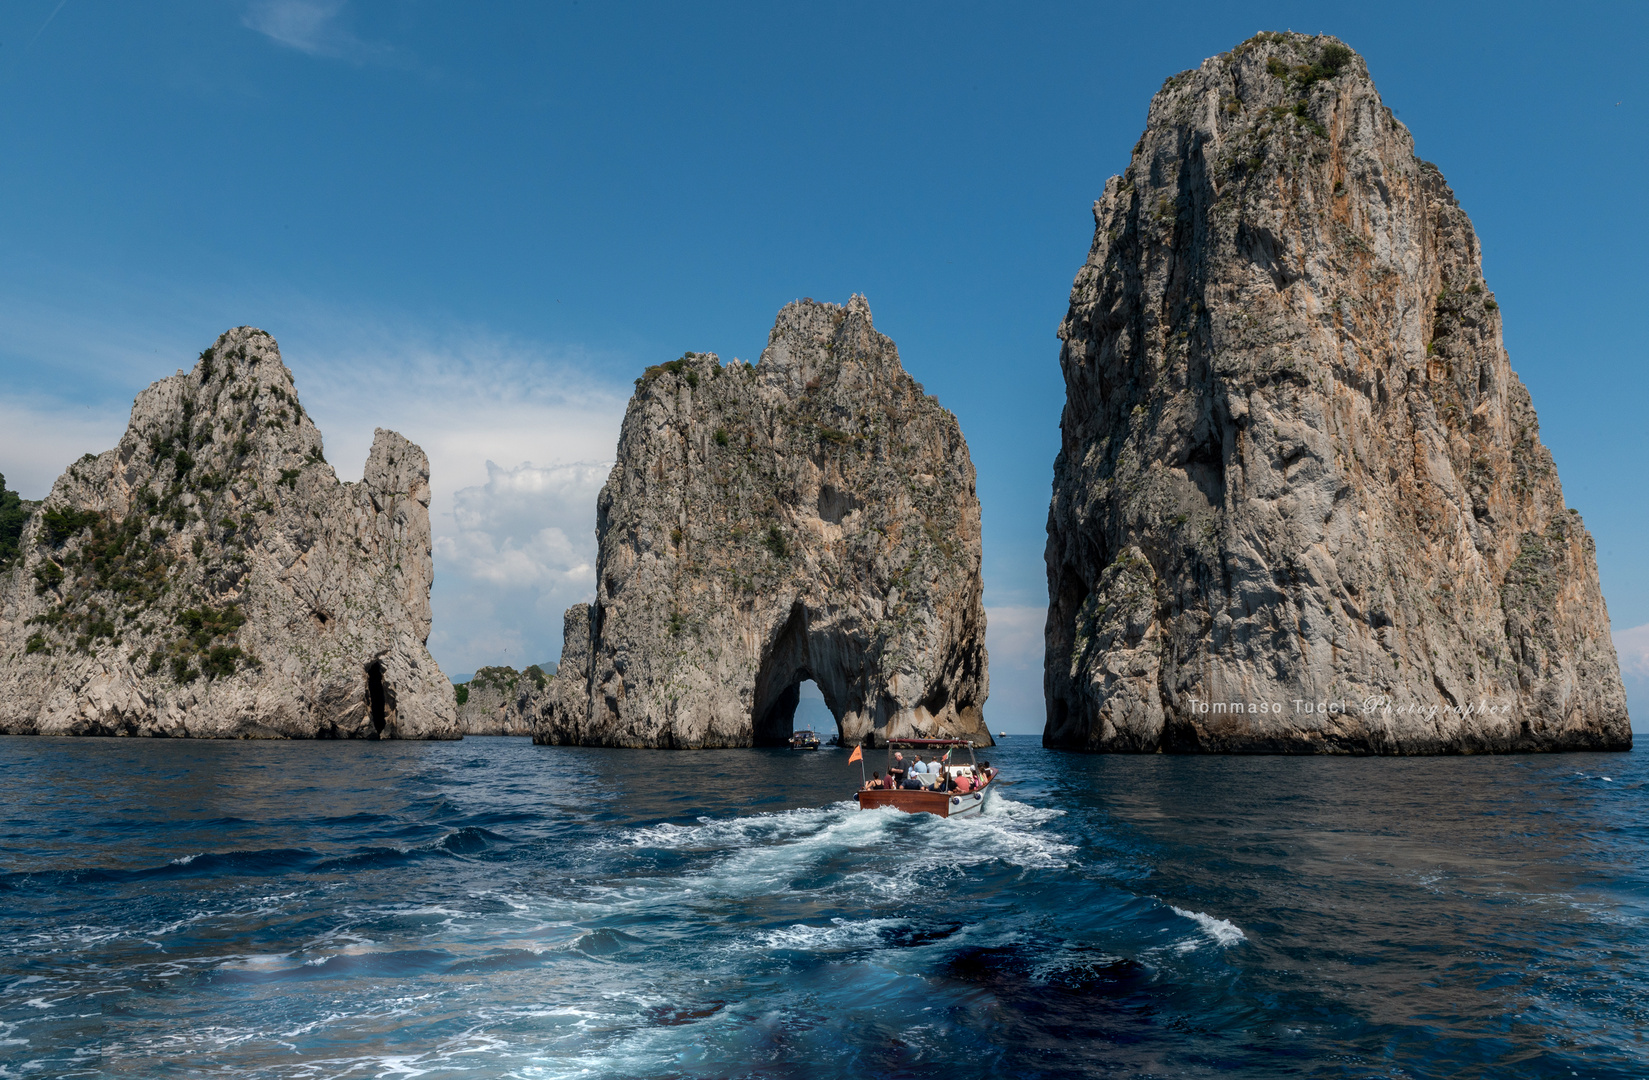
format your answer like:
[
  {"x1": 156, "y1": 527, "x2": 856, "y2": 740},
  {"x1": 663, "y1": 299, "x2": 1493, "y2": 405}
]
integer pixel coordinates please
[{"x1": 0, "y1": 326, "x2": 458, "y2": 739}]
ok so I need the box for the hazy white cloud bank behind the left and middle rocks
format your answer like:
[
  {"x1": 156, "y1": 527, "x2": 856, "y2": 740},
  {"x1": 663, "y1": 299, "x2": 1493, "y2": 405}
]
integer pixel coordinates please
[{"x1": 0, "y1": 283, "x2": 635, "y2": 673}]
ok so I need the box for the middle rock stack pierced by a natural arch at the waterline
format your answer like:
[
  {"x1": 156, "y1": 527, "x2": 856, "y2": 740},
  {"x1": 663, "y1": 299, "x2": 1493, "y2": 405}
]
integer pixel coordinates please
[{"x1": 534, "y1": 297, "x2": 989, "y2": 747}]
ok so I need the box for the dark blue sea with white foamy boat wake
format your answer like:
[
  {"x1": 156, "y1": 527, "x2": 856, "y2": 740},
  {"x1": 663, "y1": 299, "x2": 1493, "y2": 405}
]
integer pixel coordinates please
[{"x1": 0, "y1": 737, "x2": 1649, "y2": 1080}]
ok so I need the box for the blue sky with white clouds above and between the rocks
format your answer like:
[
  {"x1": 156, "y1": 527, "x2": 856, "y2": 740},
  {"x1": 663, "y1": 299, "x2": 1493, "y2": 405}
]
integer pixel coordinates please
[{"x1": 0, "y1": 0, "x2": 1649, "y2": 734}]
